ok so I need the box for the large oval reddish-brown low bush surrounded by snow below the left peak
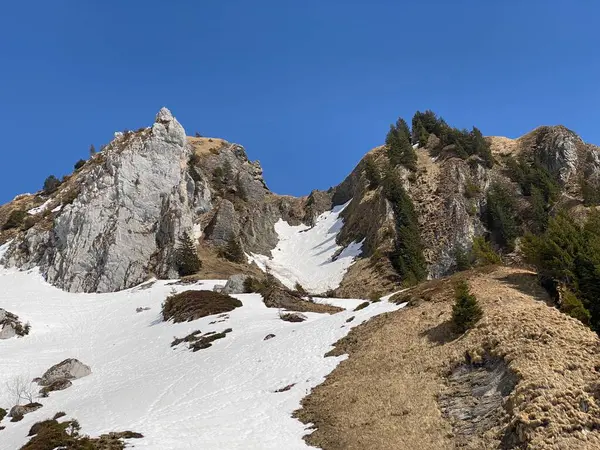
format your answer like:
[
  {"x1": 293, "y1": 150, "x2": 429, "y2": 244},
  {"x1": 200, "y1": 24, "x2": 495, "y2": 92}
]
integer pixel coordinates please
[{"x1": 162, "y1": 291, "x2": 242, "y2": 323}]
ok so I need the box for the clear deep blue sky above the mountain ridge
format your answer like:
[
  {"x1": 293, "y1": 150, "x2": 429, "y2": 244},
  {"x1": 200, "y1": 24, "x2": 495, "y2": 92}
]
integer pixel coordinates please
[{"x1": 0, "y1": 0, "x2": 600, "y2": 203}]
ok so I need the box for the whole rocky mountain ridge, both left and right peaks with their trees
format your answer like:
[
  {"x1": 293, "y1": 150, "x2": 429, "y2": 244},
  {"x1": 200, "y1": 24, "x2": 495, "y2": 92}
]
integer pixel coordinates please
[{"x1": 0, "y1": 108, "x2": 600, "y2": 314}]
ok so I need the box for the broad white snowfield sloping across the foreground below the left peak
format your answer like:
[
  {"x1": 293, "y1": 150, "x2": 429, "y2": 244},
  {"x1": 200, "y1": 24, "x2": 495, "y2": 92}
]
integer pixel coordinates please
[{"x1": 0, "y1": 243, "x2": 398, "y2": 450}]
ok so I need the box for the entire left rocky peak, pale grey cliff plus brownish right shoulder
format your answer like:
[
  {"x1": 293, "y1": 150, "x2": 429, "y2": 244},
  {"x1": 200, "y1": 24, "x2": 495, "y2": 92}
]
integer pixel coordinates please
[{"x1": 0, "y1": 108, "x2": 328, "y2": 292}]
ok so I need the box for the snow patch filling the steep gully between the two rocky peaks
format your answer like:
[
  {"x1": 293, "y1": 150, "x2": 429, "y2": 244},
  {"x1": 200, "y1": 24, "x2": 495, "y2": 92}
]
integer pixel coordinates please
[{"x1": 250, "y1": 202, "x2": 362, "y2": 293}]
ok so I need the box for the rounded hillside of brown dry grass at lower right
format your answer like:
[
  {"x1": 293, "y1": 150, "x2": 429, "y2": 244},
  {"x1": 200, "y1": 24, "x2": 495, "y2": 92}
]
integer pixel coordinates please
[{"x1": 297, "y1": 268, "x2": 600, "y2": 450}]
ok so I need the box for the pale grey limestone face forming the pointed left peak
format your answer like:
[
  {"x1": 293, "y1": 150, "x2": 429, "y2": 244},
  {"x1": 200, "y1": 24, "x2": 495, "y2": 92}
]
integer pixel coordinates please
[{"x1": 2, "y1": 108, "x2": 207, "y2": 292}]
